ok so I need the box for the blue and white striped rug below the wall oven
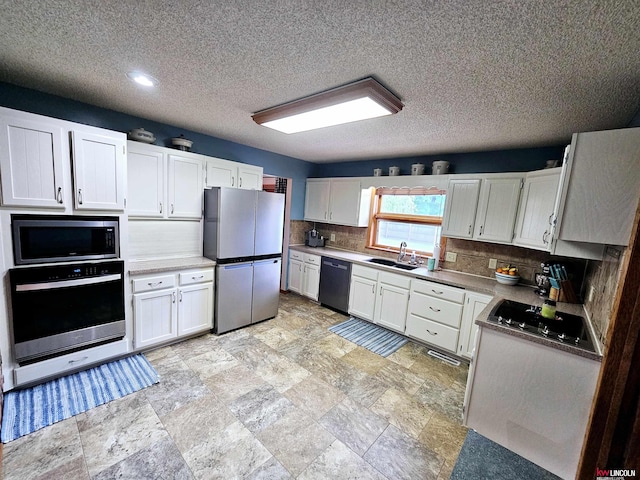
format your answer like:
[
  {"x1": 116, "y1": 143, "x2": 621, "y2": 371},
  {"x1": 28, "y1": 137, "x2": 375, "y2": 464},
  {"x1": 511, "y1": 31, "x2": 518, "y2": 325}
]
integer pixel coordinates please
[{"x1": 2, "y1": 354, "x2": 160, "y2": 443}]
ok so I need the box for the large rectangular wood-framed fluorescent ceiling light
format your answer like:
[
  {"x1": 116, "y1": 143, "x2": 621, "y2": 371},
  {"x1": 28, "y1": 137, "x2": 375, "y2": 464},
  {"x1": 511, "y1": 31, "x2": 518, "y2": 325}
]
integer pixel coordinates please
[{"x1": 252, "y1": 77, "x2": 403, "y2": 133}]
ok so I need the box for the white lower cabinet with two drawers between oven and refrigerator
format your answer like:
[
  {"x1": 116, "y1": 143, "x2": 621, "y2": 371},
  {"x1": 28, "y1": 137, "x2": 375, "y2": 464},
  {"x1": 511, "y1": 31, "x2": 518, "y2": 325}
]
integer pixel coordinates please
[{"x1": 133, "y1": 268, "x2": 213, "y2": 349}]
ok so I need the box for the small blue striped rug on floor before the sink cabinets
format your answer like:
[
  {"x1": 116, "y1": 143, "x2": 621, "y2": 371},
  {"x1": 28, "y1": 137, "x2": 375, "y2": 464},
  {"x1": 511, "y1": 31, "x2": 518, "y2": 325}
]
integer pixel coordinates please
[{"x1": 329, "y1": 317, "x2": 409, "y2": 357}]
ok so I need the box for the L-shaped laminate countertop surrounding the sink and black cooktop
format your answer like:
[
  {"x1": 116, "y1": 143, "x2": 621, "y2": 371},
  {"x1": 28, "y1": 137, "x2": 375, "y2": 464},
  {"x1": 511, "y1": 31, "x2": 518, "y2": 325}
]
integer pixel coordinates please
[{"x1": 289, "y1": 245, "x2": 602, "y2": 361}]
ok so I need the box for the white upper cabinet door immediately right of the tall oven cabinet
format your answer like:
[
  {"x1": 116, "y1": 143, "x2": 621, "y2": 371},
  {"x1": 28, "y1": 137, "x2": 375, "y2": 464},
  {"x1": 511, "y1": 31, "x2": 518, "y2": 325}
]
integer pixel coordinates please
[{"x1": 127, "y1": 142, "x2": 167, "y2": 218}]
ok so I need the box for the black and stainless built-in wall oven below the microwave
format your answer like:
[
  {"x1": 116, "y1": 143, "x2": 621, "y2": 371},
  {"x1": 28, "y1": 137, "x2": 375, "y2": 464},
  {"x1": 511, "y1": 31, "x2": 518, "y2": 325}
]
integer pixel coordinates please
[{"x1": 9, "y1": 260, "x2": 125, "y2": 364}]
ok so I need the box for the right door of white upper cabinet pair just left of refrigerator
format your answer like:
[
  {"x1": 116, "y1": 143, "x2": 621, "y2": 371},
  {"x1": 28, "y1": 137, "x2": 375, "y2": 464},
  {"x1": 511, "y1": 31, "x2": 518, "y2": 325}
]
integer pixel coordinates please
[{"x1": 167, "y1": 155, "x2": 203, "y2": 218}]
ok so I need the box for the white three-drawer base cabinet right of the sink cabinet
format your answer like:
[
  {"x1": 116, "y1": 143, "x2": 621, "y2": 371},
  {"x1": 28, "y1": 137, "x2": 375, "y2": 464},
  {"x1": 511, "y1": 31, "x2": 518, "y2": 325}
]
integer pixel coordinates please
[{"x1": 405, "y1": 279, "x2": 465, "y2": 353}]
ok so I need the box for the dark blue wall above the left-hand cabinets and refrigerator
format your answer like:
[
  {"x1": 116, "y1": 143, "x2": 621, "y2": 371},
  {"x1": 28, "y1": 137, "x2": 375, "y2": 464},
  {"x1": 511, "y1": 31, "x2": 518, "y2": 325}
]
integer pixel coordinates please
[{"x1": 0, "y1": 82, "x2": 315, "y2": 220}]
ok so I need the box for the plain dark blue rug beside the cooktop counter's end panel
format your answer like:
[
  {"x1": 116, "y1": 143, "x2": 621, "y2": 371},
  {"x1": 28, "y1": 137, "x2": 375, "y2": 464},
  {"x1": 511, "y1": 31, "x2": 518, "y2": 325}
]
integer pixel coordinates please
[{"x1": 449, "y1": 430, "x2": 560, "y2": 480}]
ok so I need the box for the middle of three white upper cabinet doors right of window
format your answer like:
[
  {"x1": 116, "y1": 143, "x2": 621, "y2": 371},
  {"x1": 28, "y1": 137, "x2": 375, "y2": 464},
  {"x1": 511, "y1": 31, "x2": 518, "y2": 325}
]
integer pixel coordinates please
[{"x1": 474, "y1": 177, "x2": 522, "y2": 243}]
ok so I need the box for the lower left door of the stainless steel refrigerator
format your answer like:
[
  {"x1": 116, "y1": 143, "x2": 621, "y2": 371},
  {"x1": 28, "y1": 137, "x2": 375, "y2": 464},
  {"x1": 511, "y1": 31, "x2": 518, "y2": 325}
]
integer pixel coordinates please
[{"x1": 214, "y1": 262, "x2": 253, "y2": 334}]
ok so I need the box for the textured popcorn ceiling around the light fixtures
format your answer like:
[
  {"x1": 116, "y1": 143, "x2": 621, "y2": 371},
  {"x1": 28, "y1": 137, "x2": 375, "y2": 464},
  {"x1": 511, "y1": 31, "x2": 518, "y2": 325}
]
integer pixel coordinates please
[{"x1": 0, "y1": 0, "x2": 640, "y2": 162}]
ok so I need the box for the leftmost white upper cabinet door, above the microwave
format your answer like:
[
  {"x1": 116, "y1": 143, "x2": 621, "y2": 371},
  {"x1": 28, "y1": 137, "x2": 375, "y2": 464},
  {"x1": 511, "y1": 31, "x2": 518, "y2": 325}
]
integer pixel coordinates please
[{"x1": 0, "y1": 115, "x2": 68, "y2": 208}]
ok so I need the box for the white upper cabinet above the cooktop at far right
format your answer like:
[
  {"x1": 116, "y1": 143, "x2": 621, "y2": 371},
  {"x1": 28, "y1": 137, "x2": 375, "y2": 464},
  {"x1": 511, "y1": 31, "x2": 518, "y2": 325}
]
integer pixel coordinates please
[{"x1": 554, "y1": 128, "x2": 640, "y2": 248}]
